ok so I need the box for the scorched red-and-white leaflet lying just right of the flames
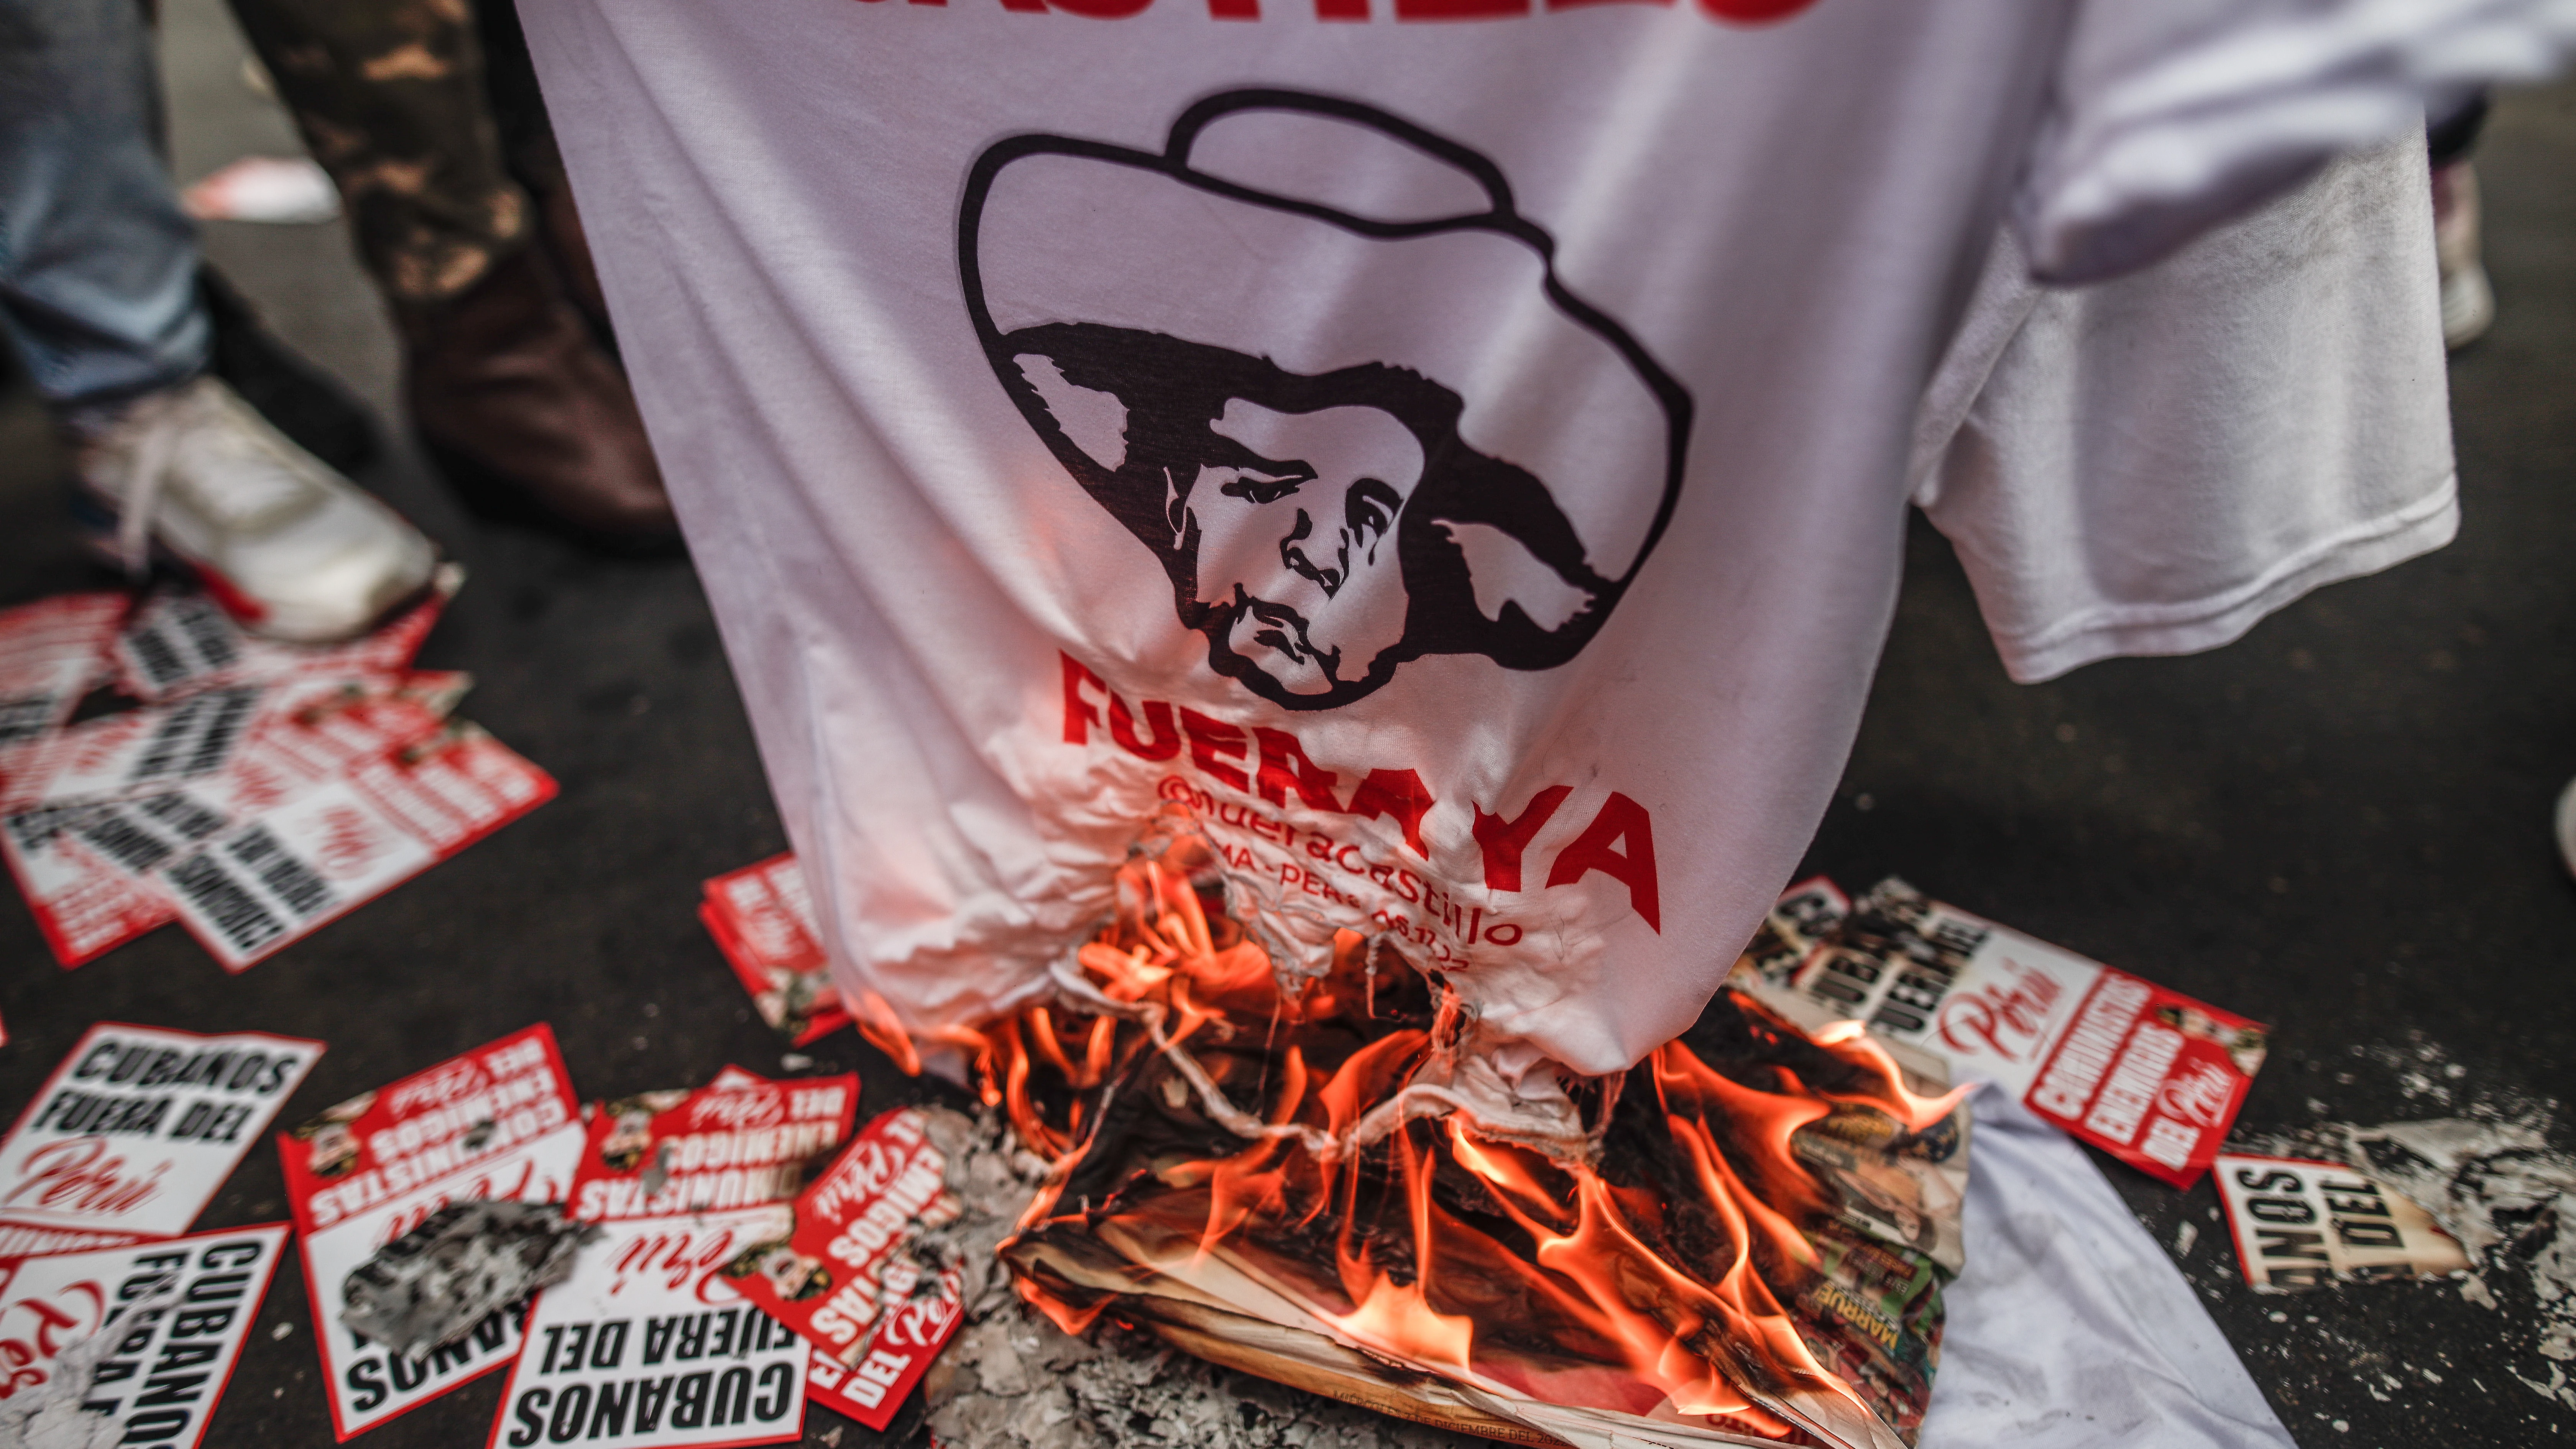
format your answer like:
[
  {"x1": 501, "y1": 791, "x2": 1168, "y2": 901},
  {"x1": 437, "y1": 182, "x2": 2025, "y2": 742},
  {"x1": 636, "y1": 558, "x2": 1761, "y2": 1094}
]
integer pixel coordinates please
[{"x1": 1736, "y1": 879, "x2": 2267, "y2": 1186}]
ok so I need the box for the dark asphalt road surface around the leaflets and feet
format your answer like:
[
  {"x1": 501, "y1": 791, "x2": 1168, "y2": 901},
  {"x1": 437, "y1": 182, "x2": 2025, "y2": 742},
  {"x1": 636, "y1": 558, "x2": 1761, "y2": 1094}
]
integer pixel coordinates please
[{"x1": 0, "y1": 0, "x2": 2576, "y2": 1449}]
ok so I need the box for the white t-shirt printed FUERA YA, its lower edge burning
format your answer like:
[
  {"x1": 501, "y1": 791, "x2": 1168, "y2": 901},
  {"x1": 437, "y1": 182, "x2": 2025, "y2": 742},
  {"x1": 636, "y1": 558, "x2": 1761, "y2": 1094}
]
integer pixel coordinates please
[{"x1": 523, "y1": 0, "x2": 2576, "y2": 1093}]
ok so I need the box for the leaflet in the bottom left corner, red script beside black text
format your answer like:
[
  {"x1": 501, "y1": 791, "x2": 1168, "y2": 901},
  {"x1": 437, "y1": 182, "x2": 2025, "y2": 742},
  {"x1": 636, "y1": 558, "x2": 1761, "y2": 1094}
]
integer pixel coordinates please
[{"x1": 0, "y1": 1222, "x2": 286, "y2": 1449}]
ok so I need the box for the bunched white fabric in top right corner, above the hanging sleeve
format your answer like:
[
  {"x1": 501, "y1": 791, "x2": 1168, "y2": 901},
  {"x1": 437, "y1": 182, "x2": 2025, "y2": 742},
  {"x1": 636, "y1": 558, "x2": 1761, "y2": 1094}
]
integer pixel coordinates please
[{"x1": 2012, "y1": 0, "x2": 2576, "y2": 284}]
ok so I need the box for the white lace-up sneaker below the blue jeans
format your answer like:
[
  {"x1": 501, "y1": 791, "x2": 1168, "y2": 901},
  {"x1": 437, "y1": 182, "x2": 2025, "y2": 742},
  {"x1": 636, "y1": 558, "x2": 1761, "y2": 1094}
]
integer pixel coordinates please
[{"x1": 80, "y1": 376, "x2": 438, "y2": 644}]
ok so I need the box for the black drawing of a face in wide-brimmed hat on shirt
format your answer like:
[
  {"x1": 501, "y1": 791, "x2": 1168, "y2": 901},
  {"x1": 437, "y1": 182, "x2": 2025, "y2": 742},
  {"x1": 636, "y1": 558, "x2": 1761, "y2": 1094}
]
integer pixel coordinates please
[{"x1": 958, "y1": 90, "x2": 1690, "y2": 709}]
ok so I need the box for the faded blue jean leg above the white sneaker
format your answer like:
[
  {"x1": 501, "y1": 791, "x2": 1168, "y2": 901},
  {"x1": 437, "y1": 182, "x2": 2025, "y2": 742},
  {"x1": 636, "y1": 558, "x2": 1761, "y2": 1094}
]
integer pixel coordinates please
[{"x1": 0, "y1": 0, "x2": 211, "y2": 407}]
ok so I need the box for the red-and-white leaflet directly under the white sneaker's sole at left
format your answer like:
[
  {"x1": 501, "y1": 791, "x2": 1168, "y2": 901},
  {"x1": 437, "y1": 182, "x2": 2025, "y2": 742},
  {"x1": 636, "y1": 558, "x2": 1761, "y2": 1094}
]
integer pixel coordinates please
[{"x1": 113, "y1": 562, "x2": 466, "y2": 701}]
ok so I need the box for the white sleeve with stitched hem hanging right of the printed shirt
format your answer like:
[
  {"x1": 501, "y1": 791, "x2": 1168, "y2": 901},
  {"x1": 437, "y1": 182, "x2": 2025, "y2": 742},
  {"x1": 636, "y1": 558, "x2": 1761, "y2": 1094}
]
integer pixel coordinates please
[{"x1": 1911, "y1": 139, "x2": 2458, "y2": 683}]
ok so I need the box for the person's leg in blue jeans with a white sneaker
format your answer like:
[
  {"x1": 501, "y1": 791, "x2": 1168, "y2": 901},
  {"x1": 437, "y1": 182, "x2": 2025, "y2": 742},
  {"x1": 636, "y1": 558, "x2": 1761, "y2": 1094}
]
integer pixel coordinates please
[{"x1": 0, "y1": 0, "x2": 435, "y2": 639}]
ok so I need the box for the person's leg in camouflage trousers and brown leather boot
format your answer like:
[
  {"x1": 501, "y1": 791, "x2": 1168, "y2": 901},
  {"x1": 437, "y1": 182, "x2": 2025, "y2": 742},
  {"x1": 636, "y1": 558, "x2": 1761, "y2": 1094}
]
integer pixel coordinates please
[{"x1": 232, "y1": 0, "x2": 675, "y2": 541}]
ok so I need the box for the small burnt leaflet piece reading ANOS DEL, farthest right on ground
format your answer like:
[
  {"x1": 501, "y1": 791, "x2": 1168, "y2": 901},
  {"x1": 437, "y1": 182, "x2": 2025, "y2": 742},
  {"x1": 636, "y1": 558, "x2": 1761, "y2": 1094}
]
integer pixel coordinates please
[{"x1": 2215, "y1": 1153, "x2": 2473, "y2": 1292}]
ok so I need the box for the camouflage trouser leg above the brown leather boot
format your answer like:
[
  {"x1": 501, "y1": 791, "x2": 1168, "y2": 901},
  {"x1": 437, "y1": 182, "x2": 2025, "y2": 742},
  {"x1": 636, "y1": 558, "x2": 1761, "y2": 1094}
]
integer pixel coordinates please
[{"x1": 232, "y1": 0, "x2": 531, "y2": 307}]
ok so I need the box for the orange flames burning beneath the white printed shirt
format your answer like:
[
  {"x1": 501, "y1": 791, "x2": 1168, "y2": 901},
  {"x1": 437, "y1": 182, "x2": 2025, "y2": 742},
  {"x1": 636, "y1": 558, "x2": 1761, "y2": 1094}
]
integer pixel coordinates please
[{"x1": 896, "y1": 841, "x2": 1960, "y2": 1439}]
